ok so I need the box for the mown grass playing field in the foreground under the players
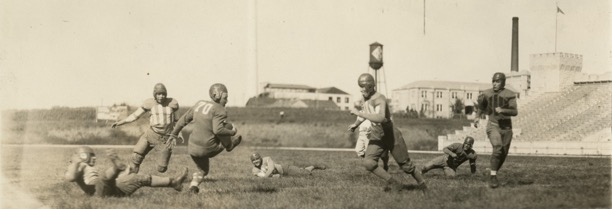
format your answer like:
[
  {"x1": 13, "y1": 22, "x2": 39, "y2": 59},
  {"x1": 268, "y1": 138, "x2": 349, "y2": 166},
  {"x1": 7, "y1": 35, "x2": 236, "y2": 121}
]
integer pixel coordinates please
[{"x1": 0, "y1": 145, "x2": 612, "y2": 208}]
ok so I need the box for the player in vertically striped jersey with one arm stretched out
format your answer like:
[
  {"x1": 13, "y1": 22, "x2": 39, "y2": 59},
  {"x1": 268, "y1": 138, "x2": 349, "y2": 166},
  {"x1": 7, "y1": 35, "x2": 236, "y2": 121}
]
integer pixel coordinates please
[{"x1": 111, "y1": 83, "x2": 179, "y2": 173}]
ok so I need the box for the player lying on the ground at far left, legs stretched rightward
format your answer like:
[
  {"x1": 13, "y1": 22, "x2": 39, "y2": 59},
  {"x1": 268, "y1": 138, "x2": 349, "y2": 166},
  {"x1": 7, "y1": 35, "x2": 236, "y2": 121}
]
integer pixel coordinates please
[{"x1": 65, "y1": 146, "x2": 187, "y2": 197}]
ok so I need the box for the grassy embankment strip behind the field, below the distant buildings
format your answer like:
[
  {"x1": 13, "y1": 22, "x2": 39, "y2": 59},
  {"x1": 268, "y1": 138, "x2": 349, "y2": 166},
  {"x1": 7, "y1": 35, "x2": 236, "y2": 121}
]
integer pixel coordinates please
[{"x1": 1, "y1": 107, "x2": 469, "y2": 150}]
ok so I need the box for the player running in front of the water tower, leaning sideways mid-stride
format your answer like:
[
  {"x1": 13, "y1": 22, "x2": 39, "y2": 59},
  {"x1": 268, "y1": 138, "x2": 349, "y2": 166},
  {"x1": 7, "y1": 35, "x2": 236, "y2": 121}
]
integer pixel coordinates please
[{"x1": 351, "y1": 73, "x2": 426, "y2": 191}]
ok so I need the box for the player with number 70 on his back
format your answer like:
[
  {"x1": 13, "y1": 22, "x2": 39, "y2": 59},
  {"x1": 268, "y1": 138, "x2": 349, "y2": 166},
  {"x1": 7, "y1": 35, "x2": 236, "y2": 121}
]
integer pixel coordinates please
[{"x1": 170, "y1": 83, "x2": 242, "y2": 194}]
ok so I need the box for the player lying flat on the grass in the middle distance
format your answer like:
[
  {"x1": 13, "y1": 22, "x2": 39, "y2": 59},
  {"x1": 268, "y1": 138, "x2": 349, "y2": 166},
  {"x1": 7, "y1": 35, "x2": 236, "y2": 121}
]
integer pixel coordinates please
[{"x1": 251, "y1": 153, "x2": 327, "y2": 178}]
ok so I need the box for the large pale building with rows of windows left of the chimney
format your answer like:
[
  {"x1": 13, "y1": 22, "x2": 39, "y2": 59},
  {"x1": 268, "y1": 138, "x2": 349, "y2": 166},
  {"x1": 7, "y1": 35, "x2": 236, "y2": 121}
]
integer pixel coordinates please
[{"x1": 391, "y1": 80, "x2": 491, "y2": 118}]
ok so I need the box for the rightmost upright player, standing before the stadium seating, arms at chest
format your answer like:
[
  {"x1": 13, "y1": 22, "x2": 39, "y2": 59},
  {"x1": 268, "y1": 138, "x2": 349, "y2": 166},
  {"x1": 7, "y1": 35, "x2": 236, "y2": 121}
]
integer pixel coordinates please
[{"x1": 474, "y1": 72, "x2": 518, "y2": 188}]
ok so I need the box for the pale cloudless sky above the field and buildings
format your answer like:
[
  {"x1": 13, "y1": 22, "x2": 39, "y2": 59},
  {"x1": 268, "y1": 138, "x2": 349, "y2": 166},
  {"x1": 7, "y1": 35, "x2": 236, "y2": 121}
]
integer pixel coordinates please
[{"x1": 0, "y1": 0, "x2": 612, "y2": 109}]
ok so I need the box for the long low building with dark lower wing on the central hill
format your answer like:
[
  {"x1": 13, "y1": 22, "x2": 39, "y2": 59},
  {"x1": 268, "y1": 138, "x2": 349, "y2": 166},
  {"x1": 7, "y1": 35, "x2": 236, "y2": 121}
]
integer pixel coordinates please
[{"x1": 247, "y1": 83, "x2": 352, "y2": 110}]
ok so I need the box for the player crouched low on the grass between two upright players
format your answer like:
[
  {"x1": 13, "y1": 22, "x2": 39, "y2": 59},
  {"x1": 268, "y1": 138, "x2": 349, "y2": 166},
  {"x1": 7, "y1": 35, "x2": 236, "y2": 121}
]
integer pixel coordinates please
[{"x1": 421, "y1": 136, "x2": 476, "y2": 177}]
